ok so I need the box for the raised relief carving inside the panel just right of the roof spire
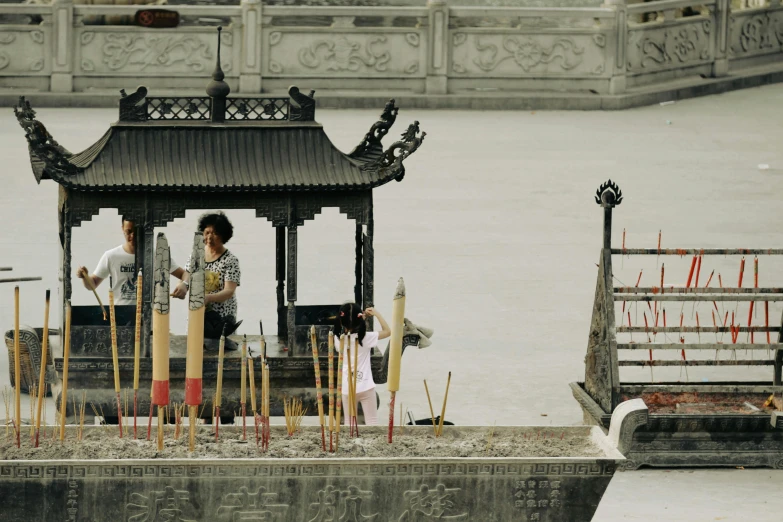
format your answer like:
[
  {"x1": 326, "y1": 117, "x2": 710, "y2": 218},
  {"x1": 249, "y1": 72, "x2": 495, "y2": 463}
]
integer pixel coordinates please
[{"x1": 299, "y1": 36, "x2": 391, "y2": 72}]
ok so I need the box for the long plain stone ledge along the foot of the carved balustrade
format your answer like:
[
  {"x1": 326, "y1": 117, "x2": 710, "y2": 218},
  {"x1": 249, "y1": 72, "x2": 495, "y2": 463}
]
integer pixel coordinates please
[{"x1": 6, "y1": 64, "x2": 783, "y2": 110}]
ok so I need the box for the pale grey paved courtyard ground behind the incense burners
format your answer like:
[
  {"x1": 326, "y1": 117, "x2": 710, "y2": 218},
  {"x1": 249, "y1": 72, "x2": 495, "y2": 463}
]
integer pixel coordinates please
[{"x1": 0, "y1": 85, "x2": 783, "y2": 522}]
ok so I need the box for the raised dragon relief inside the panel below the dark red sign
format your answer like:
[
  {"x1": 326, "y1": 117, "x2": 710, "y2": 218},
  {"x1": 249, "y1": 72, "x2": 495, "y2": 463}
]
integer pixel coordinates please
[{"x1": 96, "y1": 33, "x2": 224, "y2": 72}]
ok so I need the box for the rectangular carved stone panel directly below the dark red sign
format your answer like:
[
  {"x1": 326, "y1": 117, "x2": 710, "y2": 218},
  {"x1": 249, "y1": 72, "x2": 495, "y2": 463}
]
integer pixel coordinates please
[{"x1": 75, "y1": 27, "x2": 238, "y2": 76}]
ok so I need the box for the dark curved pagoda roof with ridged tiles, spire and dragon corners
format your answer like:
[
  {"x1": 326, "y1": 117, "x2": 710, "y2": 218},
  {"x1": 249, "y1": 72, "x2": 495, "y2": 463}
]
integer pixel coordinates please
[{"x1": 14, "y1": 51, "x2": 426, "y2": 192}]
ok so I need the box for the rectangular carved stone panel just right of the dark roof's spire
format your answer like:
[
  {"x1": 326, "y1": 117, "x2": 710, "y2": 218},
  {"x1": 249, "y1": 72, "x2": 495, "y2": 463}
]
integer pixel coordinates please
[{"x1": 264, "y1": 29, "x2": 427, "y2": 78}]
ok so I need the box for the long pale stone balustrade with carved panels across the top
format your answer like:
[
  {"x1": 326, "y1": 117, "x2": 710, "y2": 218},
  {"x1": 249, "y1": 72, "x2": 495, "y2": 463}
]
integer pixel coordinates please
[{"x1": 0, "y1": 0, "x2": 783, "y2": 95}]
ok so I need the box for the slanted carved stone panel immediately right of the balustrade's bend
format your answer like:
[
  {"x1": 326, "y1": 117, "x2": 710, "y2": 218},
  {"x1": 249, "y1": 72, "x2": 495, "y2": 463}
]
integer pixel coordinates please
[{"x1": 627, "y1": 17, "x2": 715, "y2": 73}]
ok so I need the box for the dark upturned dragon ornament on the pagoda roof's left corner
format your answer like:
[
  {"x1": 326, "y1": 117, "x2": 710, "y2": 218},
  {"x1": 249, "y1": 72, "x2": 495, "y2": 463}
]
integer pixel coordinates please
[{"x1": 14, "y1": 96, "x2": 80, "y2": 183}]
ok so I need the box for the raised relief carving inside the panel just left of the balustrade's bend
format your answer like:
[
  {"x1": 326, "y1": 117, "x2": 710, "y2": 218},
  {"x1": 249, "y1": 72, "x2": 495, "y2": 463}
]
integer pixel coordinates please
[{"x1": 473, "y1": 36, "x2": 585, "y2": 73}]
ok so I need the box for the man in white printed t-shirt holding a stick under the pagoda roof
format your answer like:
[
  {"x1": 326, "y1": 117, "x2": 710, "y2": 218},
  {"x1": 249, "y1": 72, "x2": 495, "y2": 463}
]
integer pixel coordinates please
[{"x1": 76, "y1": 218, "x2": 185, "y2": 306}]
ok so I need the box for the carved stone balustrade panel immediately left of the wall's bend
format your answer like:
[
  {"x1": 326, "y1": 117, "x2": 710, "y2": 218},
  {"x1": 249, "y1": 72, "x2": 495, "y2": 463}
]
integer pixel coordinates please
[{"x1": 449, "y1": 31, "x2": 611, "y2": 78}]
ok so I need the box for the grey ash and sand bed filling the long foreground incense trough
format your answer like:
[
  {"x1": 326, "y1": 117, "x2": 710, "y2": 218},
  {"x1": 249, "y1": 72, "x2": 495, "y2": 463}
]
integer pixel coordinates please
[{"x1": 0, "y1": 425, "x2": 604, "y2": 460}]
